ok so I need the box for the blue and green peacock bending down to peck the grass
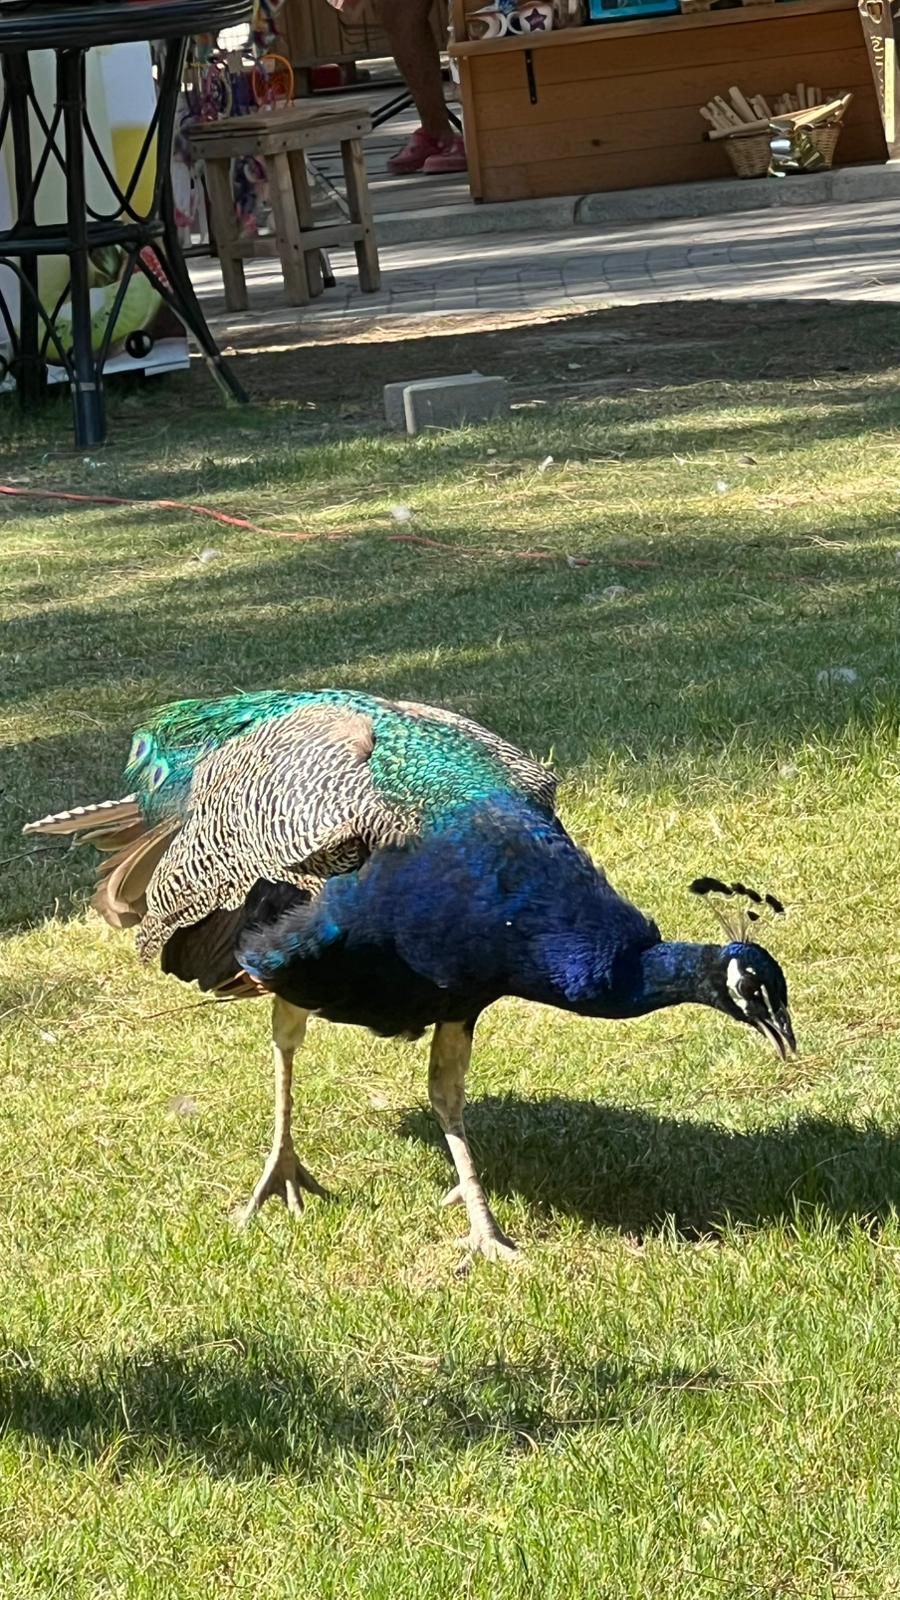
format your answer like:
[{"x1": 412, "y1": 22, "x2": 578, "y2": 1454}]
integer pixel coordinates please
[{"x1": 26, "y1": 690, "x2": 796, "y2": 1264}]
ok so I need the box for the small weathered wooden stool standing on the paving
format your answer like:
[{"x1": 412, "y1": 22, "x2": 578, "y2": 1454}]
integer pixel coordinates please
[{"x1": 189, "y1": 102, "x2": 381, "y2": 310}]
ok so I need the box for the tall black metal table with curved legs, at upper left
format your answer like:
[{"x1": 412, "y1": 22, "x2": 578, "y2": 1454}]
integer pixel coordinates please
[{"x1": 0, "y1": 0, "x2": 251, "y2": 446}]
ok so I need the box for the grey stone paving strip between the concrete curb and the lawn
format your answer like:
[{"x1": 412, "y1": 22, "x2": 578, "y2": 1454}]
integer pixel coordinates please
[{"x1": 192, "y1": 198, "x2": 900, "y2": 338}]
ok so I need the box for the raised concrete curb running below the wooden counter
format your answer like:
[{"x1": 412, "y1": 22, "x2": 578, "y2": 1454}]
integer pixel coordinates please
[{"x1": 375, "y1": 162, "x2": 900, "y2": 245}]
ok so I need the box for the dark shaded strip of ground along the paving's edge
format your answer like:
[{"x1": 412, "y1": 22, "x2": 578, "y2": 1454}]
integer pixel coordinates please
[{"x1": 185, "y1": 291, "x2": 897, "y2": 422}]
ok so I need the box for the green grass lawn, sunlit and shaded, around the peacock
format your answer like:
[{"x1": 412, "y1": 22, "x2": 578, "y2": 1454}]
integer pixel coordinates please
[{"x1": 0, "y1": 306, "x2": 900, "y2": 1600}]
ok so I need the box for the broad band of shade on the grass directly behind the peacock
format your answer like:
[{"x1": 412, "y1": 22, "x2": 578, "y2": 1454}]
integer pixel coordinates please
[{"x1": 0, "y1": 480, "x2": 897, "y2": 928}]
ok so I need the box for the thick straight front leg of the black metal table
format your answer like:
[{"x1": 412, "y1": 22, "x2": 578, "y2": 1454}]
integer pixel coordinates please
[{"x1": 56, "y1": 50, "x2": 106, "y2": 448}]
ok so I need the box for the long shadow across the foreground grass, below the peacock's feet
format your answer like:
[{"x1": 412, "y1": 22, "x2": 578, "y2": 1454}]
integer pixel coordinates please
[{"x1": 0, "y1": 1334, "x2": 729, "y2": 1480}]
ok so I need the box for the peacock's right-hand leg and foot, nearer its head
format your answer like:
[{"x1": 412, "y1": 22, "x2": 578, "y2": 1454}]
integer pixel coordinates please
[{"x1": 428, "y1": 1022, "x2": 519, "y2": 1272}]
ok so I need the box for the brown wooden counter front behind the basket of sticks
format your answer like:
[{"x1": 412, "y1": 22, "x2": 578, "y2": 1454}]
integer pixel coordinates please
[{"x1": 450, "y1": 0, "x2": 887, "y2": 200}]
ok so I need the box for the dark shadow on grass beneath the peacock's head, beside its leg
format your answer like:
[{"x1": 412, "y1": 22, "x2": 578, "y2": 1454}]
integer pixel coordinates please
[{"x1": 400, "y1": 1096, "x2": 900, "y2": 1238}]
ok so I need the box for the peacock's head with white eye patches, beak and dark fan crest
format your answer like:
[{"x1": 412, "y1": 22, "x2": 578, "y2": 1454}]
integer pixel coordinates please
[{"x1": 690, "y1": 878, "x2": 798, "y2": 1059}]
